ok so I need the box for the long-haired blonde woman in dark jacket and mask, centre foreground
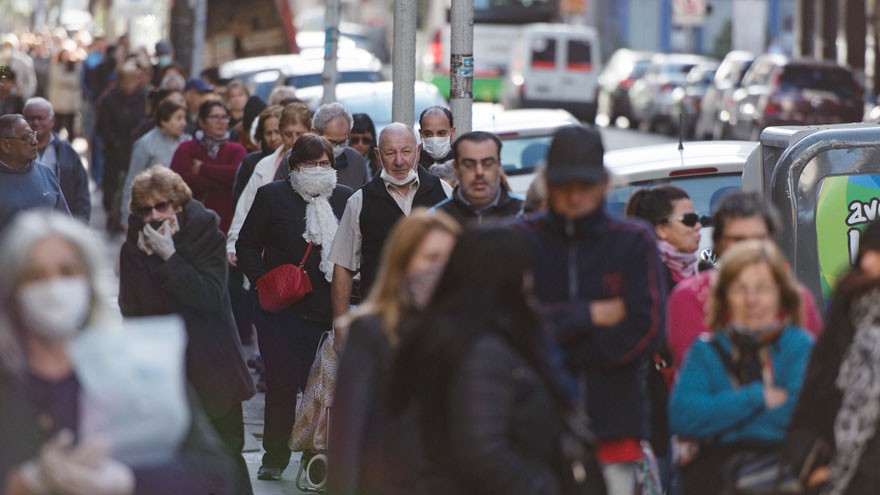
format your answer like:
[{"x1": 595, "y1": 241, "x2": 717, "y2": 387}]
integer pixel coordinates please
[{"x1": 327, "y1": 209, "x2": 461, "y2": 495}]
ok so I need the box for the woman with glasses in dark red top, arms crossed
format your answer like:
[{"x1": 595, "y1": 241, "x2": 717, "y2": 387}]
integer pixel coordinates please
[{"x1": 171, "y1": 100, "x2": 247, "y2": 234}]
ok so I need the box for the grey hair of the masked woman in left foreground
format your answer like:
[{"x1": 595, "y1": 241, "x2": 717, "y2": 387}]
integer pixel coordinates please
[{"x1": 0, "y1": 210, "x2": 113, "y2": 375}]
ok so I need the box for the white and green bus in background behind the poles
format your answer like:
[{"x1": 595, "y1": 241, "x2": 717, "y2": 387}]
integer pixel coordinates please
[{"x1": 423, "y1": 0, "x2": 559, "y2": 102}]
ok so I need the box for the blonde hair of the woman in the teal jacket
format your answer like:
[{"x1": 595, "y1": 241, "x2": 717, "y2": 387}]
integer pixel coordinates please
[{"x1": 706, "y1": 240, "x2": 801, "y2": 330}]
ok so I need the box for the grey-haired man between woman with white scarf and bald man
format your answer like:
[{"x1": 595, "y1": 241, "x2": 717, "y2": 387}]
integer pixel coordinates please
[{"x1": 312, "y1": 103, "x2": 368, "y2": 189}]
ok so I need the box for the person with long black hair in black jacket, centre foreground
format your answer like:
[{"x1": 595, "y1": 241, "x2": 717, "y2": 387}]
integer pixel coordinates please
[{"x1": 392, "y1": 227, "x2": 602, "y2": 495}]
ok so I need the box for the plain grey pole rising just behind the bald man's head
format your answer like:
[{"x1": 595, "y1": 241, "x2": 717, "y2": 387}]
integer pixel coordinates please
[{"x1": 391, "y1": 0, "x2": 418, "y2": 127}]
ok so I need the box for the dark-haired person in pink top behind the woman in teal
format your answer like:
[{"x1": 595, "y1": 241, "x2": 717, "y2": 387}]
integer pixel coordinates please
[{"x1": 666, "y1": 191, "x2": 822, "y2": 374}]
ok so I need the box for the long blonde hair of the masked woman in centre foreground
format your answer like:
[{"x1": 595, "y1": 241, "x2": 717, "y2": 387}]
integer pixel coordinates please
[{"x1": 352, "y1": 208, "x2": 461, "y2": 346}]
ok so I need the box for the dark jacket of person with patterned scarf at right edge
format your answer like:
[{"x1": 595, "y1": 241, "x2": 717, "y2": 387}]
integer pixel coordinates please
[{"x1": 785, "y1": 280, "x2": 880, "y2": 495}]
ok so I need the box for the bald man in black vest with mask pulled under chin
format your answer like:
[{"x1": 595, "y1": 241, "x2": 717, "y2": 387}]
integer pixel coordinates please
[{"x1": 329, "y1": 122, "x2": 452, "y2": 350}]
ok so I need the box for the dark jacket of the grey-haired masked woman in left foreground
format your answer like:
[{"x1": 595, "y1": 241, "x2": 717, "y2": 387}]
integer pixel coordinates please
[{"x1": 0, "y1": 375, "x2": 241, "y2": 495}]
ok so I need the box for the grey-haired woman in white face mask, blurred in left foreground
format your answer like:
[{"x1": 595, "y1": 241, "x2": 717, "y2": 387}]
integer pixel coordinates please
[{"x1": 0, "y1": 211, "x2": 241, "y2": 495}]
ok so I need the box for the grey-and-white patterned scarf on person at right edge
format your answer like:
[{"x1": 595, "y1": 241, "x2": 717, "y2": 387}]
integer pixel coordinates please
[{"x1": 823, "y1": 290, "x2": 880, "y2": 495}]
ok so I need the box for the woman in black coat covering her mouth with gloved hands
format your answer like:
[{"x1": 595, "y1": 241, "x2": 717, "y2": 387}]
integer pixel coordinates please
[{"x1": 119, "y1": 167, "x2": 255, "y2": 493}]
